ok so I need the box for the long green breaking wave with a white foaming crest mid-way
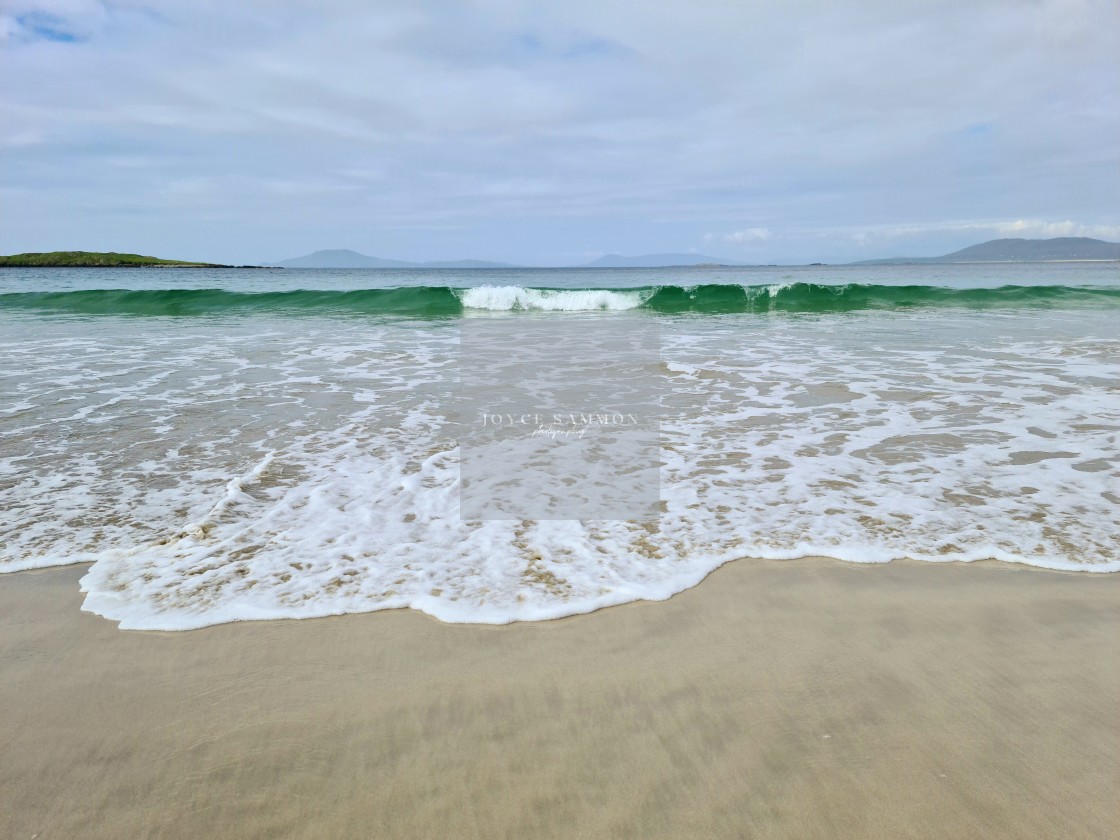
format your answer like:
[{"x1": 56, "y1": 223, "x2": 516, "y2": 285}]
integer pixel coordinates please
[{"x1": 0, "y1": 283, "x2": 1120, "y2": 318}]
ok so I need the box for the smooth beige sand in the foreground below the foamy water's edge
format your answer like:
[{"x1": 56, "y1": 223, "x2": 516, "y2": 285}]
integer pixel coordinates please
[{"x1": 0, "y1": 560, "x2": 1120, "y2": 840}]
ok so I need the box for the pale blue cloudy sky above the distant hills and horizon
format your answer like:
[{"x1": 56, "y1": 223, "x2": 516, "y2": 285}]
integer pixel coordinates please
[{"x1": 0, "y1": 0, "x2": 1120, "y2": 265}]
